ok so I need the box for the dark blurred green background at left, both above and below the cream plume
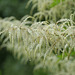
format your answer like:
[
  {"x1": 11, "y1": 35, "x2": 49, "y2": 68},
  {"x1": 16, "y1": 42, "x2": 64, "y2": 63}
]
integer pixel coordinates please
[{"x1": 0, "y1": 0, "x2": 33, "y2": 75}]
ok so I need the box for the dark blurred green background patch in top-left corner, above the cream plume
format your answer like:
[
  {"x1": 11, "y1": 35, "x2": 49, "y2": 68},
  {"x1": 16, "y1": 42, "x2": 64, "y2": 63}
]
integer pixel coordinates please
[{"x1": 0, "y1": 0, "x2": 31, "y2": 19}]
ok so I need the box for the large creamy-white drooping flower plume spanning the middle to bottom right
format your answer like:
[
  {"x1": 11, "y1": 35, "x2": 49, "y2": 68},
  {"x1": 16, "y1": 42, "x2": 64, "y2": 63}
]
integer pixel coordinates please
[{"x1": 0, "y1": 14, "x2": 75, "y2": 75}]
